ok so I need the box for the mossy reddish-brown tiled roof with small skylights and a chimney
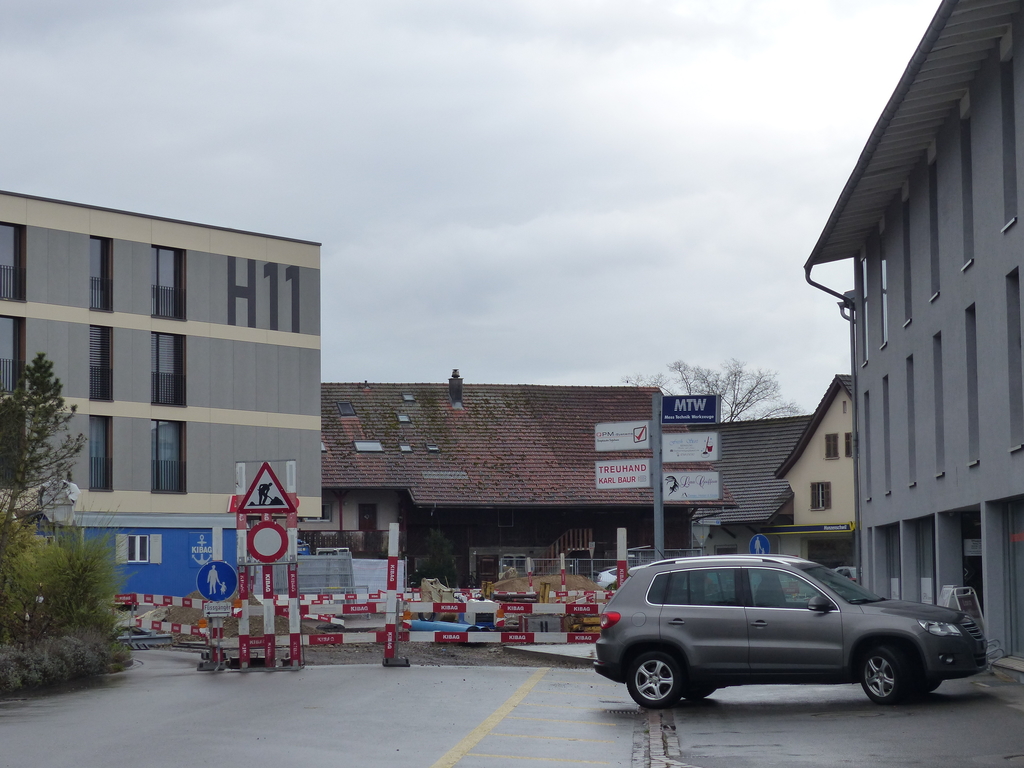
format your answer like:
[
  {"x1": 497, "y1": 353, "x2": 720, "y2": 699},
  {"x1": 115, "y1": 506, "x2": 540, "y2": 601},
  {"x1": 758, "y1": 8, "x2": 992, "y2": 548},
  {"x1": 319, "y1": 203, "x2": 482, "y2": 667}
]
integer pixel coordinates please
[{"x1": 321, "y1": 383, "x2": 728, "y2": 507}]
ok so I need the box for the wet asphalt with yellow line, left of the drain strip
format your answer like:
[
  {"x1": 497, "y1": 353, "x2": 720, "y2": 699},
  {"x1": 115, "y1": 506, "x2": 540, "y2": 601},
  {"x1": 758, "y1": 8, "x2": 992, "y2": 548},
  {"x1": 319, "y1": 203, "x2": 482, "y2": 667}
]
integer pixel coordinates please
[{"x1": 0, "y1": 650, "x2": 641, "y2": 768}]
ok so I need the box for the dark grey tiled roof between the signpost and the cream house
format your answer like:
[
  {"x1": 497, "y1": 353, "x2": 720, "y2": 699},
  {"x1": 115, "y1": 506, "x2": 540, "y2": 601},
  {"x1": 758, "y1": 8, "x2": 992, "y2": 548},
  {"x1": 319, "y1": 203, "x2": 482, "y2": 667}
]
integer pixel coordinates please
[{"x1": 684, "y1": 416, "x2": 811, "y2": 523}]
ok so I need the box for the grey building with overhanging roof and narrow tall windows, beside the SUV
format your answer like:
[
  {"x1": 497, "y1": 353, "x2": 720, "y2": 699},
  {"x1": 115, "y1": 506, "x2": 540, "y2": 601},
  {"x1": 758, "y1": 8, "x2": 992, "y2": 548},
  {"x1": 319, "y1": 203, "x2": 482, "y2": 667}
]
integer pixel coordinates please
[{"x1": 805, "y1": 0, "x2": 1024, "y2": 656}]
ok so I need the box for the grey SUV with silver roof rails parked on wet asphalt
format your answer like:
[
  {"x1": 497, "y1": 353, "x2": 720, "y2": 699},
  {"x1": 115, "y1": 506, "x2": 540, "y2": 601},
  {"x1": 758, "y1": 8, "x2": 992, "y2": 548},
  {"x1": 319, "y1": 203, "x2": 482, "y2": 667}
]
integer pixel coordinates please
[{"x1": 594, "y1": 555, "x2": 987, "y2": 709}]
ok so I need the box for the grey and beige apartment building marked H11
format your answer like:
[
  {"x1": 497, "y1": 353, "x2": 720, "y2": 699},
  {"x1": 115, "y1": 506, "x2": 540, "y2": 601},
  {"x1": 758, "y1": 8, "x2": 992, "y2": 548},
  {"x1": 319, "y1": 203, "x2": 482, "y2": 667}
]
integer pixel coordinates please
[{"x1": 0, "y1": 193, "x2": 321, "y2": 522}]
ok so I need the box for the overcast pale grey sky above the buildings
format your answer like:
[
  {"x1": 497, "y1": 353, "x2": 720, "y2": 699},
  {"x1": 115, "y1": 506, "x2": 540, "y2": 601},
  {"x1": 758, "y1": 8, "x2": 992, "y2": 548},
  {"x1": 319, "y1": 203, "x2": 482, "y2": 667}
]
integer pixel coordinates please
[{"x1": 0, "y1": 0, "x2": 938, "y2": 412}]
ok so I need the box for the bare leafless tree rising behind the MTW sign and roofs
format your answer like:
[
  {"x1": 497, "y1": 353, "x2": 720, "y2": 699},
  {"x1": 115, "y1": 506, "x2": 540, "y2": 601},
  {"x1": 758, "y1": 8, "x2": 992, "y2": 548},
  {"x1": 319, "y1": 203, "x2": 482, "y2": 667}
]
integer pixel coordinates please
[{"x1": 623, "y1": 357, "x2": 800, "y2": 422}]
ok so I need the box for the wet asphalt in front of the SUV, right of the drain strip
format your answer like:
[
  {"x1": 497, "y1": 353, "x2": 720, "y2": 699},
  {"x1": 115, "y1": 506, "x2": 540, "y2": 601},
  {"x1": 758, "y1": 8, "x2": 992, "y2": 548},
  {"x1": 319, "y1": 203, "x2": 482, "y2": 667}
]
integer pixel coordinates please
[{"x1": 655, "y1": 675, "x2": 1024, "y2": 768}]
